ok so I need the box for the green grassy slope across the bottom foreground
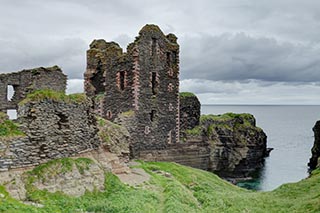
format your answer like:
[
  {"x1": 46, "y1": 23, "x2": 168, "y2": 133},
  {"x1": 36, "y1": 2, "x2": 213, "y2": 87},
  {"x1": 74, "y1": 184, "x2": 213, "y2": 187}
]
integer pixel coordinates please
[{"x1": 0, "y1": 162, "x2": 320, "y2": 213}]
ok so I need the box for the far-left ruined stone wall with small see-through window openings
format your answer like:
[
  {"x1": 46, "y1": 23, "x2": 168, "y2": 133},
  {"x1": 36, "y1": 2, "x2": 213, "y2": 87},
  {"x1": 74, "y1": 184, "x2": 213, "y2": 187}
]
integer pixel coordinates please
[{"x1": 0, "y1": 66, "x2": 67, "y2": 111}]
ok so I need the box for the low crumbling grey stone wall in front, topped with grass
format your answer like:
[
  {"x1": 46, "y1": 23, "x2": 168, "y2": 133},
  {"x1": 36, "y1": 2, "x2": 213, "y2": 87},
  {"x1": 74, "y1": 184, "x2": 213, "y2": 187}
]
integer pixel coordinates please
[{"x1": 0, "y1": 99, "x2": 100, "y2": 171}]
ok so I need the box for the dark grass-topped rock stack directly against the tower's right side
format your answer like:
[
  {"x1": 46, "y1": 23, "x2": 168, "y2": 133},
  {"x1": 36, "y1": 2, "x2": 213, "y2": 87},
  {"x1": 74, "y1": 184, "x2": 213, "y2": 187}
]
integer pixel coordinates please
[{"x1": 180, "y1": 92, "x2": 201, "y2": 131}]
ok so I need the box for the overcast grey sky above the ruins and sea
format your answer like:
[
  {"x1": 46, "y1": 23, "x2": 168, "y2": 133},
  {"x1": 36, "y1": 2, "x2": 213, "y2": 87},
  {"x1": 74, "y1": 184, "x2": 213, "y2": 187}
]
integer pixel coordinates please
[{"x1": 0, "y1": 0, "x2": 320, "y2": 104}]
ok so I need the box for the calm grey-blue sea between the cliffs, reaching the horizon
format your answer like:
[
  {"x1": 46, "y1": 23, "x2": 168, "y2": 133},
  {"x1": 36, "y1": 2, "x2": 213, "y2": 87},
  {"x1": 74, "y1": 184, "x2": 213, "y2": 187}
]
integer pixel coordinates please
[{"x1": 201, "y1": 105, "x2": 320, "y2": 191}]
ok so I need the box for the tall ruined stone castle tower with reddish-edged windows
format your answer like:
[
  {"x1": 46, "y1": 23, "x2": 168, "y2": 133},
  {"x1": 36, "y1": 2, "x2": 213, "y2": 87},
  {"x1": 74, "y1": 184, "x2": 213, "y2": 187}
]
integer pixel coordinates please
[{"x1": 84, "y1": 25, "x2": 179, "y2": 157}]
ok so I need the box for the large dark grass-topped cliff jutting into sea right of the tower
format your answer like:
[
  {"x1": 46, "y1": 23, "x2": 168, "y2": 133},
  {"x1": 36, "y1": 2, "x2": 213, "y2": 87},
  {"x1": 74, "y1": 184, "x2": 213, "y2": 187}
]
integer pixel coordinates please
[{"x1": 185, "y1": 113, "x2": 267, "y2": 178}]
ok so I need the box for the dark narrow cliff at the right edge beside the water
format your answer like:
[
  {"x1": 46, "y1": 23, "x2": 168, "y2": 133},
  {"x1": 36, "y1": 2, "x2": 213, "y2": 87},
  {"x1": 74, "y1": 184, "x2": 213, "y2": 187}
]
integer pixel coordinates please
[{"x1": 308, "y1": 121, "x2": 320, "y2": 170}]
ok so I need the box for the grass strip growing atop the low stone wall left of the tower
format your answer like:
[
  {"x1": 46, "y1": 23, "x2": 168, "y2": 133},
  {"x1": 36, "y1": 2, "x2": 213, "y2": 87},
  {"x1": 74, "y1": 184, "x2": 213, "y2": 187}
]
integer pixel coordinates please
[{"x1": 19, "y1": 90, "x2": 87, "y2": 105}]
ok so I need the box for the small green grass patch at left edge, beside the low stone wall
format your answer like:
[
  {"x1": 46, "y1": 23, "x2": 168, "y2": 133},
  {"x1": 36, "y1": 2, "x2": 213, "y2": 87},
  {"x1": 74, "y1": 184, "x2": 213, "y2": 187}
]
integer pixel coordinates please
[{"x1": 0, "y1": 112, "x2": 25, "y2": 138}]
